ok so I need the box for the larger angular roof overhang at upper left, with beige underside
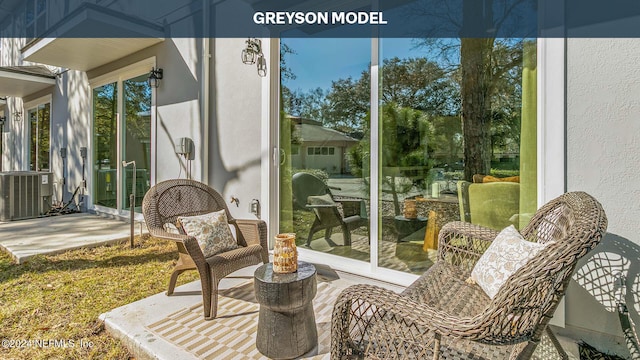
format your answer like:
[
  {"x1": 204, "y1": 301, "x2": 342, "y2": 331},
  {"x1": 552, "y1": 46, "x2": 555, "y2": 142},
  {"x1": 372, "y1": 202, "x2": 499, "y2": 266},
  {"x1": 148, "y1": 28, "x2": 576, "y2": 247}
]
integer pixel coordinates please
[{"x1": 22, "y1": 4, "x2": 165, "y2": 71}]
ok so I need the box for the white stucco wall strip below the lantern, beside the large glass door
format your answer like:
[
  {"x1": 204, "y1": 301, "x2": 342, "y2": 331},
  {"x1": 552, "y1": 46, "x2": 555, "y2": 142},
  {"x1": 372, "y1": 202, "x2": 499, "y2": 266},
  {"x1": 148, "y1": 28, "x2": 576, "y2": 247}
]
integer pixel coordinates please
[{"x1": 209, "y1": 38, "x2": 264, "y2": 219}]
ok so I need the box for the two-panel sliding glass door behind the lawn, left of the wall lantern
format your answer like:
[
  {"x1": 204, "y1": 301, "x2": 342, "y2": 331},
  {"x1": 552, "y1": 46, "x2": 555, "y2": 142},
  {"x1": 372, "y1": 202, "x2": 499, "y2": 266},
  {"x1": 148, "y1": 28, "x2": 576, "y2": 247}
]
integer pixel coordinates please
[{"x1": 92, "y1": 74, "x2": 152, "y2": 212}]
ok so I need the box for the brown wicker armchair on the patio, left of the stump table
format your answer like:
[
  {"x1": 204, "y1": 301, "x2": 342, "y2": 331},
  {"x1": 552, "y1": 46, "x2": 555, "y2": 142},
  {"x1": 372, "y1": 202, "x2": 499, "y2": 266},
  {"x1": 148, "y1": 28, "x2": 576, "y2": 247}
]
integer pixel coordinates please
[{"x1": 142, "y1": 179, "x2": 269, "y2": 320}]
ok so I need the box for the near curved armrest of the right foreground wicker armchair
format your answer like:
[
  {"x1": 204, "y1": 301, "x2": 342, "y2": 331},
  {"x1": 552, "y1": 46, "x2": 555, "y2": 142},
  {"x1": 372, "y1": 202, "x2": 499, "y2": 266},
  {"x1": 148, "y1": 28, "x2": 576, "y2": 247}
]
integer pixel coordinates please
[{"x1": 331, "y1": 284, "x2": 483, "y2": 359}]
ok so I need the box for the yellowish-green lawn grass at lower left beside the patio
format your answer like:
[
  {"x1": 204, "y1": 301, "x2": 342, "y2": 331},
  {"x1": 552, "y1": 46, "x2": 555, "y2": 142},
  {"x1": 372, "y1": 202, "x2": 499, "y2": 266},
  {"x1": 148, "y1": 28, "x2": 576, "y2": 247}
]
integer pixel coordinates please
[{"x1": 0, "y1": 238, "x2": 198, "y2": 359}]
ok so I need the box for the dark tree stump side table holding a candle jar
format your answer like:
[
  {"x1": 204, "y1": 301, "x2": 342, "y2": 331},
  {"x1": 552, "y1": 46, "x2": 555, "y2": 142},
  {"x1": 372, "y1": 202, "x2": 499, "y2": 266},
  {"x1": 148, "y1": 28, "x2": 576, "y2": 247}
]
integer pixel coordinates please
[{"x1": 253, "y1": 261, "x2": 318, "y2": 359}]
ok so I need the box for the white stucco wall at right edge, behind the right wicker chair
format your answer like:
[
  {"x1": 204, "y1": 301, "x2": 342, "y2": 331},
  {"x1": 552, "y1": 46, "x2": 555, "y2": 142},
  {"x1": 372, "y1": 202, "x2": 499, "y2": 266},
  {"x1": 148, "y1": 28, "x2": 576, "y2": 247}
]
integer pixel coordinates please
[{"x1": 558, "y1": 39, "x2": 640, "y2": 349}]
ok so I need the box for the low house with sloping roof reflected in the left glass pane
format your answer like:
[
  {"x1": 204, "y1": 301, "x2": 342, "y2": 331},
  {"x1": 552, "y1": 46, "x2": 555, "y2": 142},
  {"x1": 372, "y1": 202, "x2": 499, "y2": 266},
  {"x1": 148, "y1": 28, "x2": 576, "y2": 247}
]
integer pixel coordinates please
[{"x1": 289, "y1": 116, "x2": 358, "y2": 175}]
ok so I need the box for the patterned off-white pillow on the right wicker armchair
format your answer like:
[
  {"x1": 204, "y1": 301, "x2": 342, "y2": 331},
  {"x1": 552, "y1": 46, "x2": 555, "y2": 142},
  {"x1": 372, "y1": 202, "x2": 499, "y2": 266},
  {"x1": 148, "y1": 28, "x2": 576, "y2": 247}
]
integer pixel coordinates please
[{"x1": 471, "y1": 225, "x2": 549, "y2": 299}]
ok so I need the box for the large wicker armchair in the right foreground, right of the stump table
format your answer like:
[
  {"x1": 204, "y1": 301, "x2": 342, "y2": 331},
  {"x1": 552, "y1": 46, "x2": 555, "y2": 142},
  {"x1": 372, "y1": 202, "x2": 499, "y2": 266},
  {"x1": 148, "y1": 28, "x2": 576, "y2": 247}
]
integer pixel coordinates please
[{"x1": 331, "y1": 192, "x2": 607, "y2": 359}]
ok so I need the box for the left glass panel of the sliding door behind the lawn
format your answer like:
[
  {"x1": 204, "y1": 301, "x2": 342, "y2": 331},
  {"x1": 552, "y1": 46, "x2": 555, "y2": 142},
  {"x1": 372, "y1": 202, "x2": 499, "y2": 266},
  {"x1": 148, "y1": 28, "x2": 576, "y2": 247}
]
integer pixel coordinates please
[{"x1": 93, "y1": 82, "x2": 119, "y2": 209}]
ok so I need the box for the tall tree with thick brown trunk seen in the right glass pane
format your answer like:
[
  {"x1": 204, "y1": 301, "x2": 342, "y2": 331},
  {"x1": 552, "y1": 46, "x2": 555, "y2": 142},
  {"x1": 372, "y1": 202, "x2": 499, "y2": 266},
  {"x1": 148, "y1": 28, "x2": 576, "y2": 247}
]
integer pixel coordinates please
[{"x1": 414, "y1": 0, "x2": 526, "y2": 181}]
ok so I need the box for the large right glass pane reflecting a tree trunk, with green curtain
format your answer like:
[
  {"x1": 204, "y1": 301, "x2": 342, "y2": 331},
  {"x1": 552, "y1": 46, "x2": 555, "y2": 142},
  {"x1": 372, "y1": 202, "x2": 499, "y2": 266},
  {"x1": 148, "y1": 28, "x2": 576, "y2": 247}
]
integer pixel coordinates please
[{"x1": 378, "y1": 39, "x2": 536, "y2": 274}]
